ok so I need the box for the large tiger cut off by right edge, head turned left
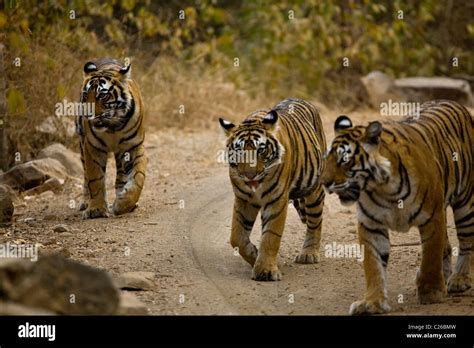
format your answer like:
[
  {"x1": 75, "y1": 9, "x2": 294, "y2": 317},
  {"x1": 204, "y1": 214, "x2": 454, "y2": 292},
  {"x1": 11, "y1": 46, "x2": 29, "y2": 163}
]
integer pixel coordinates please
[{"x1": 321, "y1": 100, "x2": 474, "y2": 315}]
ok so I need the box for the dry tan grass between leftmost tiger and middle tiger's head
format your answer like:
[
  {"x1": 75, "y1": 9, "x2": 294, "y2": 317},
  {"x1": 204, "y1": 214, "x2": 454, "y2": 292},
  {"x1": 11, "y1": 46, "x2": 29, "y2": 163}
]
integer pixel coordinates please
[{"x1": 134, "y1": 58, "x2": 271, "y2": 129}]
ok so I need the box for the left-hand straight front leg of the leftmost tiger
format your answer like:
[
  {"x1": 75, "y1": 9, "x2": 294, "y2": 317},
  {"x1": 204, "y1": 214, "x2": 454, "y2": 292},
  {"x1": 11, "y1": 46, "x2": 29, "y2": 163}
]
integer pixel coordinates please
[{"x1": 81, "y1": 143, "x2": 107, "y2": 219}]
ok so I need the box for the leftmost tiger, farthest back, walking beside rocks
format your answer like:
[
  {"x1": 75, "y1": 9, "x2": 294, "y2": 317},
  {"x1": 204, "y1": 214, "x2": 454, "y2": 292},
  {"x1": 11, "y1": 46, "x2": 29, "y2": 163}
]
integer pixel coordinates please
[{"x1": 76, "y1": 58, "x2": 147, "y2": 219}]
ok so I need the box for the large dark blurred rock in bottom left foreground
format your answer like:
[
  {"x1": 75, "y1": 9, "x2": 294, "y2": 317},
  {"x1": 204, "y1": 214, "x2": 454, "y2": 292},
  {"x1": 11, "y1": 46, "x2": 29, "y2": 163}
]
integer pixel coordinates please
[{"x1": 0, "y1": 254, "x2": 120, "y2": 315}]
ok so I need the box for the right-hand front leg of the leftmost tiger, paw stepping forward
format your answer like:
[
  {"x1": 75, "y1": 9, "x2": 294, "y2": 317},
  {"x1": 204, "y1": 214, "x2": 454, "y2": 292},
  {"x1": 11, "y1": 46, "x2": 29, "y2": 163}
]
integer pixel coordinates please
[{"x1": 111, "y1": 144, "x2": 146, "y2": 215}]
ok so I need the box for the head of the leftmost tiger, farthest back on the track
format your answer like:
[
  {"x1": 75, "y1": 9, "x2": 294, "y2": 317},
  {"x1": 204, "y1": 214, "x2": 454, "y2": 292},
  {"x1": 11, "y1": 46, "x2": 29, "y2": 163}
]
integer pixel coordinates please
[{"x1": 81, "y1": 59, "x2": 135, "y2": 132}]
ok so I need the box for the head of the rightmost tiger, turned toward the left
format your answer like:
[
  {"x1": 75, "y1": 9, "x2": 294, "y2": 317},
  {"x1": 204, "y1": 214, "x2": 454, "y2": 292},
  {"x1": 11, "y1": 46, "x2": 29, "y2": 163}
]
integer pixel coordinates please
[{"x1": 320, "y1": 116, "x2": 391, "y2": 205}]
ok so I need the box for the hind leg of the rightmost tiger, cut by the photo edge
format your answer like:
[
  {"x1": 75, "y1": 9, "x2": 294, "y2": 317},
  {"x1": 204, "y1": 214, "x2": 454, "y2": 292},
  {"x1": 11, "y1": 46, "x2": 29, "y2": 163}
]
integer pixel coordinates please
[{"x1": 448, "y1": 194, "x2": 474, "y2": 292}]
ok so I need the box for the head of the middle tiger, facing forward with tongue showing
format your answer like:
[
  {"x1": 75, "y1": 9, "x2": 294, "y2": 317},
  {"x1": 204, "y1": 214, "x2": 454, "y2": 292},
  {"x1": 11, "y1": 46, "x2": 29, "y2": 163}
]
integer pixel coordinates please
[{"x1": 219, "y1": 110, "x2": 284, "y2": 192}]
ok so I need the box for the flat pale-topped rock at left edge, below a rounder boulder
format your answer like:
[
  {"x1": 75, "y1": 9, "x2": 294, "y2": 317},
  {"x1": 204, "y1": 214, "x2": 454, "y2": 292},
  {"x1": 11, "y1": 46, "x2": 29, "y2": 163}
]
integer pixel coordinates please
[{"x1": 0, "y1": 158, "x2": 67, "y2": 191}]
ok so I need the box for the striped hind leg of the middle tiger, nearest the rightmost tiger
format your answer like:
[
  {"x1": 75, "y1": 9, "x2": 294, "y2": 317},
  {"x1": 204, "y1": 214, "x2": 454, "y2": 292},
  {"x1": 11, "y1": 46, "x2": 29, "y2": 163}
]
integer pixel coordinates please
[{"x1": 295, "y1": 186, "x2": 324, "y2": 264}]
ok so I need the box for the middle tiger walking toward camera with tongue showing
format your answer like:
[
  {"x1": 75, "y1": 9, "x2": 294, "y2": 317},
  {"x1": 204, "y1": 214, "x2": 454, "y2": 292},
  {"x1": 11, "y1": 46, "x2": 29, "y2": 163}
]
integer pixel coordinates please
[{"x1": 219, "y1": 99, "x2": 326, "y2": 281}]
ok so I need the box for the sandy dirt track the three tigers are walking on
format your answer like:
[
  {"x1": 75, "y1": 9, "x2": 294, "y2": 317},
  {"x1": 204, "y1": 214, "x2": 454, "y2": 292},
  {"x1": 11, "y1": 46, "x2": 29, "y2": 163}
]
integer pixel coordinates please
[{"x1": 0, "y1": 106, "x2": 474, "y2": 315}]
